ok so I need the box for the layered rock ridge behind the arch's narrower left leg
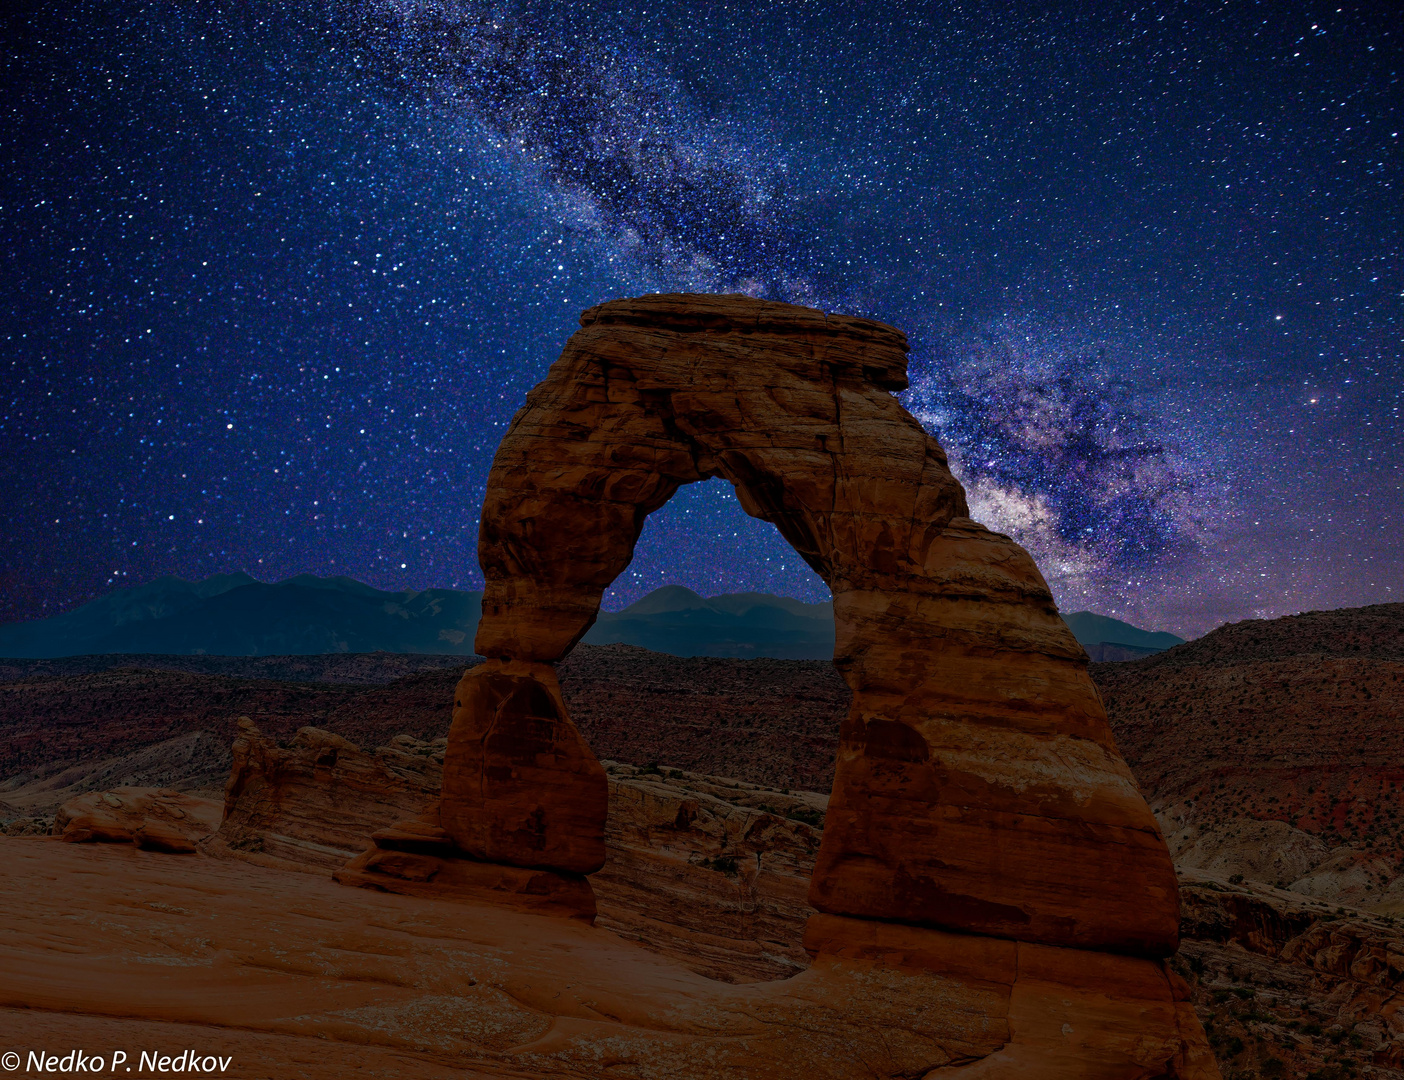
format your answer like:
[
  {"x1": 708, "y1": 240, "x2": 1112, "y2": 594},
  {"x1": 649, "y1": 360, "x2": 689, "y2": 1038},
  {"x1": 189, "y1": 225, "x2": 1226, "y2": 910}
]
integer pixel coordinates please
[{"x1": 202, "y1": 720, "x2": 828, "y2": 982}]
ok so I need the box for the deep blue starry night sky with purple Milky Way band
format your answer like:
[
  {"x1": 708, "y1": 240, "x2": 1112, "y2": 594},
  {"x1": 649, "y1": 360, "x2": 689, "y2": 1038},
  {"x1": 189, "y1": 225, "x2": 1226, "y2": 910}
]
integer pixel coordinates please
[{"x1": 0, "y1": 0, "x2": 1404, "y2": 635}]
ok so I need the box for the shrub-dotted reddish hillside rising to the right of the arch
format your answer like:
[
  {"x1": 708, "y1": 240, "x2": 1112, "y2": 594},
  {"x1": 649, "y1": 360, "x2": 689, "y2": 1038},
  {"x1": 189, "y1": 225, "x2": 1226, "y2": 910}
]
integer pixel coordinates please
[{"x1": 1094, "y1": 604, "x2": 1404, "y2": 913}]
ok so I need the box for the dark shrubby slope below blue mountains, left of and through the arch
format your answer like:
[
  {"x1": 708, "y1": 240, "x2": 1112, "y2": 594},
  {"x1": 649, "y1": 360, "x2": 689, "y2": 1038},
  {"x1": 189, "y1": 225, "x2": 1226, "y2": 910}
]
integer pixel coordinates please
[{"x1": 0, "y1": 645, "x2": 848, "y2": 815}]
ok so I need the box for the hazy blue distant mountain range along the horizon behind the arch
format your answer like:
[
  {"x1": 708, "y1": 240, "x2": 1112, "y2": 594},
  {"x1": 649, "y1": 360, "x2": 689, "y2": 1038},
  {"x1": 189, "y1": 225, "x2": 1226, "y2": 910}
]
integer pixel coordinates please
[{"x1": 0, "y1": 573, "x2": 1182, "y2": 660}]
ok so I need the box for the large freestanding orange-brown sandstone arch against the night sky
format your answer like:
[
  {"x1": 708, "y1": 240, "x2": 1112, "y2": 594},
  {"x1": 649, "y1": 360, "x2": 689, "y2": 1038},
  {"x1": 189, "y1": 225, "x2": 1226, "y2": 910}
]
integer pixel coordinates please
[{"x1": 439, "y1": 295, "x2": 1178, "y2": 956}]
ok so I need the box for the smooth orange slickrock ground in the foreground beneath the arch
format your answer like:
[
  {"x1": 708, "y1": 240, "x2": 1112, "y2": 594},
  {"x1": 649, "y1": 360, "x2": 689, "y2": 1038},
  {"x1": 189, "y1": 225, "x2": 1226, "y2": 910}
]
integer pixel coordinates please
[{"x1": 0, "y1": 837, "x2": 1205, "y2": 1080}]
